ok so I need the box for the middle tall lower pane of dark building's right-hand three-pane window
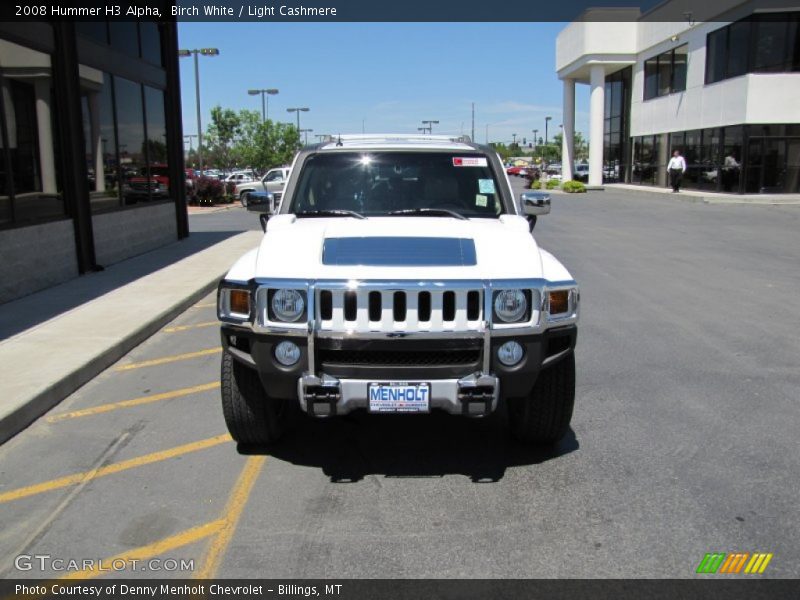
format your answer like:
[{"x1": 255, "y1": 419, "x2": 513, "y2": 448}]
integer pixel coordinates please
[{"x1": 114, "y1": 77, "x2": 147, "y2": 204}]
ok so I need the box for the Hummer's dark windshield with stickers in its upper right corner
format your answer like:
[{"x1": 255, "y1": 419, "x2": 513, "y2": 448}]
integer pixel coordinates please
[{"x1": 289, "y1": 152, "x2": 505, "y2": 217}]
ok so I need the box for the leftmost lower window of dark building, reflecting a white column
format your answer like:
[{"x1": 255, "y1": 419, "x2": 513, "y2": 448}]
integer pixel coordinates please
[{"x1": 0, "y1": 40, "x2": 66, "y2": 224}]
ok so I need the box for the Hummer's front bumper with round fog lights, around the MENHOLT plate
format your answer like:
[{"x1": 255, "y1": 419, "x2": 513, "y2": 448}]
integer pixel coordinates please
[{"x1": 222, "y1": 324, "x2": 577, "y2": 417}]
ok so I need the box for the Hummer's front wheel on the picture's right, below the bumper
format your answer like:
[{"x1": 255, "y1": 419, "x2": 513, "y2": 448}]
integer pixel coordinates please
[{"x1": 508, "y1": 354, "x2": 575, "y2": 444}]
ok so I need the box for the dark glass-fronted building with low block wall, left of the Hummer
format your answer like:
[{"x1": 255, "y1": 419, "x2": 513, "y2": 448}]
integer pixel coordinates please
[{"x1": 0, "y1": 15, "x2": 188, "y2": 303}]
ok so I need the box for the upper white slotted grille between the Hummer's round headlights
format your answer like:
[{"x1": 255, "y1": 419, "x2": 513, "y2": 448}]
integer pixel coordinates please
[{"x1": 317, "y1": 284, "x2": 483, "y2": 333}]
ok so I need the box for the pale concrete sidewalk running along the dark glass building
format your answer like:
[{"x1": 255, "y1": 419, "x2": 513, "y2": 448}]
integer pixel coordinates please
[{"x1": 0, "y1": 231, "x2": 262, "y2": 443}]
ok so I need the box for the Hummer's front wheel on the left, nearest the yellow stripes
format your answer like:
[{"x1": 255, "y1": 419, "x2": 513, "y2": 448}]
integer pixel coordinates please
[{"x1": 221, "y1": 352, "x2": 287, "y2": 444}]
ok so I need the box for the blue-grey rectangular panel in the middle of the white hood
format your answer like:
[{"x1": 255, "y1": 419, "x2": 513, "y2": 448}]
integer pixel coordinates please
[{"x1": 322, "y1": 237, "x2": 478, "y2": 267}]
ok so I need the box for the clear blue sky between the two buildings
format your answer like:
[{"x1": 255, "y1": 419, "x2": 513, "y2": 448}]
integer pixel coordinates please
[{"x1": 178, "y1": 22, "x2": 589, "y2": 143}]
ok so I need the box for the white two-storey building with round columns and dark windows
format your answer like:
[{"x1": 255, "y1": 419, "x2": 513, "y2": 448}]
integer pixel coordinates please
[{"x1": 556, "y1": 0, "x2": 800, "y2": 194}]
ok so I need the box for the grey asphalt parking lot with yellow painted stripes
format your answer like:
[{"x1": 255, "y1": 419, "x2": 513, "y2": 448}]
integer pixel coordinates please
[{"x1": 0, "y1": 182, "x2": 800, "y2": 578}]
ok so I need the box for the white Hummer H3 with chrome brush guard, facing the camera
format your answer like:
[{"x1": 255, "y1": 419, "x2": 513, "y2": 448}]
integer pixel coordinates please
[{"x1": 217, "y1": 135, "x2": 580, "y2": 445}]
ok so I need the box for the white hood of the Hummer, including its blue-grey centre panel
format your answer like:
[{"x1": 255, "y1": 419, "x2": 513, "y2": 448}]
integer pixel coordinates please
[{"x1": 256, "y1": 215, "x2": 542, "y2": 280}]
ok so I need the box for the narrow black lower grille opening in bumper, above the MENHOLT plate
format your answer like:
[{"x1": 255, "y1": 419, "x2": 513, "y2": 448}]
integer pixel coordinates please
[{"x1": 319, "y1": 348, "x2": 481, "y2": 367}]
